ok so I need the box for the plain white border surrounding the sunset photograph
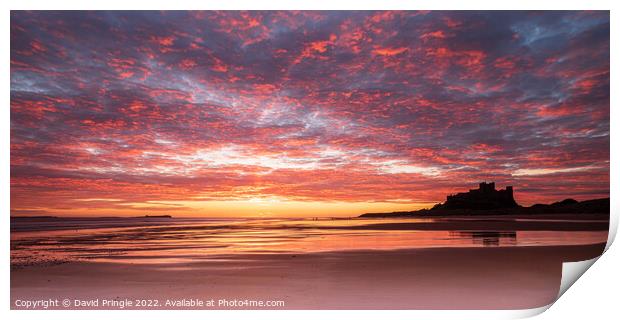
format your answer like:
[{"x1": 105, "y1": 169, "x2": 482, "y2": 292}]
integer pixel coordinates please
[{"x1": 0, "y1": 0, "x2": 620, "y2": 319}]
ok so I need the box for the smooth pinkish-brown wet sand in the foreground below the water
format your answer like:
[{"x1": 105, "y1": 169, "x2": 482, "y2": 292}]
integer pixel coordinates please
[{"x1": 11, "y1": 243, "x2": 605, "y2": 309}]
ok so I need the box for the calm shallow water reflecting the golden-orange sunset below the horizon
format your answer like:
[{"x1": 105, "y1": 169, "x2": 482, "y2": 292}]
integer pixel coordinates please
[{"x1": 11, "y1": 218, "x2": 607, "y2": 266}]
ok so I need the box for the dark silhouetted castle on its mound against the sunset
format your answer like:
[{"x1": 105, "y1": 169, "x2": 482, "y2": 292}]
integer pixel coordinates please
[{"x1": 433, "y1": 182, "x2": 519, "y2": 210}]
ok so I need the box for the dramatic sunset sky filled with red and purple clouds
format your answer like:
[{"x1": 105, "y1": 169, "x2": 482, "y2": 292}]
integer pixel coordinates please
[{"x1": 10, "y1": 11, "x2": 610, "y2": 217}]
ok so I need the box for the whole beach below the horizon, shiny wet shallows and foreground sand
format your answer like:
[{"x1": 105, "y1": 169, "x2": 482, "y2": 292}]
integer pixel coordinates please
[{"x1": 11, "y1": 217, "x2": 607, "y2": 309}]
